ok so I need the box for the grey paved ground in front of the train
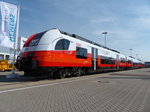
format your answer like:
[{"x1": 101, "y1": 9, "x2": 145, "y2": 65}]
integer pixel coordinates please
[{"x1": 0, "y1": 69, "x2": 150, "y2": 112}]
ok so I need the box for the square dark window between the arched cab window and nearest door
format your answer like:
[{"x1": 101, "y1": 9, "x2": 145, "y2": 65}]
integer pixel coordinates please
[{"x1": 76, "y1": 47, "x2": 87, "y2": 59}]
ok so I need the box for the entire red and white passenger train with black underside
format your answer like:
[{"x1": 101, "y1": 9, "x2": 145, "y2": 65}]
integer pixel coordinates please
[{"x1": 15, "y1": 29, "x2": 144, "y2": 77}]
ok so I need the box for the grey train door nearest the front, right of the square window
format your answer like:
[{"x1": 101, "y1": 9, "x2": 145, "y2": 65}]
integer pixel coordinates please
[{"x1": 92, "y1": 47, "x2": 98, "y2": 70}]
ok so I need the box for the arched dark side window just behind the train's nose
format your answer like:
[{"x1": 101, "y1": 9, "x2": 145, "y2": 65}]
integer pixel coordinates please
[{"x1": 55, "y1": 39, "x2": 70, "y2": 50}]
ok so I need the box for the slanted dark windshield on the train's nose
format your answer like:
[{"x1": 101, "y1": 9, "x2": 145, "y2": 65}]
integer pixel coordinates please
[{"x1": 29, "y1": 32, "x2": 46, "y2": 46}]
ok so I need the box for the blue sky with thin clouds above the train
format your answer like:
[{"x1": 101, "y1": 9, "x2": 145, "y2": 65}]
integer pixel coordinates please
[{"x1": 3, "y1": 0, "x2": 150, "y2": 61}]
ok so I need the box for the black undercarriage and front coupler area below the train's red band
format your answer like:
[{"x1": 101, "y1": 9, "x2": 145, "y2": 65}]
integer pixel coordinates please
[{"x1": 15, "y1": 58, "x2": 131, "y2": 79}]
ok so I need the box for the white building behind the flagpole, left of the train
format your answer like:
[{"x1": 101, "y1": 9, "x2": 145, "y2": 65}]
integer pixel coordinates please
[{"x1": 0, "y1": 37, "x2": 27, "y2": 62}]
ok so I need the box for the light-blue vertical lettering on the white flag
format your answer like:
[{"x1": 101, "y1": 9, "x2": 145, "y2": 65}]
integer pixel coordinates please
[{"x1": 9, "y1": 14, "x2": 15, "y2": 42}]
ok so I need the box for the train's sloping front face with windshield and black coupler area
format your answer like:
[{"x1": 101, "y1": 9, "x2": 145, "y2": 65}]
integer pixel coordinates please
[{"x1": 15, "y1": 32, "x2": 45, "y2": 75}]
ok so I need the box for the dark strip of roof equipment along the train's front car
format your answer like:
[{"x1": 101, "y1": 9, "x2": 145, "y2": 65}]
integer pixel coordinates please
[{"x1": 59, "y1": 30, "x2": 120, "y2": 53}]
